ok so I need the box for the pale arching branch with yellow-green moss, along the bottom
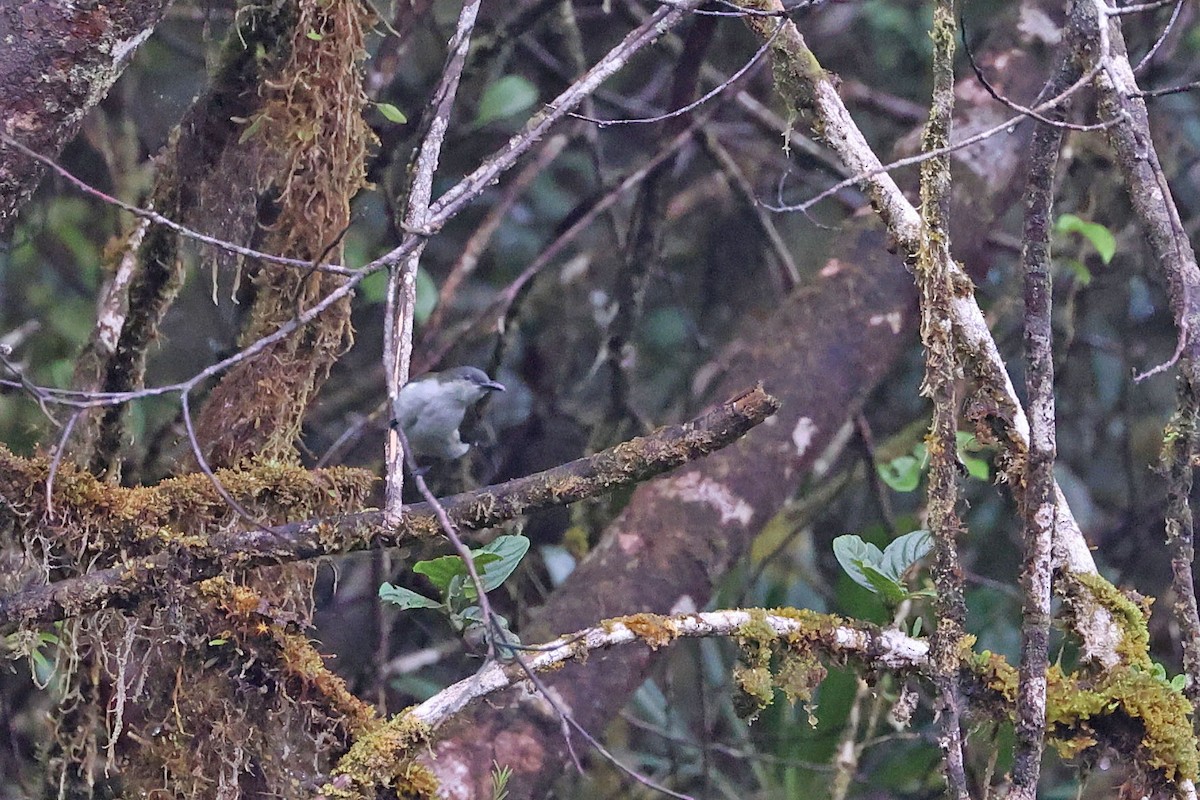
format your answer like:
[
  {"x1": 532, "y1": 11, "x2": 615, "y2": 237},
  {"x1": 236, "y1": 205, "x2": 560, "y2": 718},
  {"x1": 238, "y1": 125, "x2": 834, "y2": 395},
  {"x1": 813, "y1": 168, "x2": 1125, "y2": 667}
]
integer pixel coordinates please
[{"x1": 322, "y1": 601, "x2": 1196, "y2": 800}]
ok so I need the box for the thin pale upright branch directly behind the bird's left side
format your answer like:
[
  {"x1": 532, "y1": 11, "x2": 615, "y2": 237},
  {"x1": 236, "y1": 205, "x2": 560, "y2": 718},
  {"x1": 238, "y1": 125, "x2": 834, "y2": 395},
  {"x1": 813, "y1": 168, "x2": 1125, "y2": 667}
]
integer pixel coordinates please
[{"x1": 383, "y1": 0, "x2": 481, "y2": 521}]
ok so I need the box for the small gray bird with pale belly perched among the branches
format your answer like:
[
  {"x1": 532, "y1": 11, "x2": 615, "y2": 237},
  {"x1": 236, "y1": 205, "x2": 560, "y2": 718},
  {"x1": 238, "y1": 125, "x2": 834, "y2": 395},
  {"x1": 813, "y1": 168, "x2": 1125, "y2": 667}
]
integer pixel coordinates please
[{"x1": 392, "y1": 367, "x2": 504, "y2": 461}]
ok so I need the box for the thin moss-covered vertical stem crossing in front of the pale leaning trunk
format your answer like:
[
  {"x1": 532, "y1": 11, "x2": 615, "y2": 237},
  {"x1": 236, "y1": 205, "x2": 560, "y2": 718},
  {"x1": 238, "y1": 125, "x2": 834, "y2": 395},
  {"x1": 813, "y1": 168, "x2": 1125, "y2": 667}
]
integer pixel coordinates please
[{"x1": 917, "y1": 0, "x2": 968, "y2": 799}]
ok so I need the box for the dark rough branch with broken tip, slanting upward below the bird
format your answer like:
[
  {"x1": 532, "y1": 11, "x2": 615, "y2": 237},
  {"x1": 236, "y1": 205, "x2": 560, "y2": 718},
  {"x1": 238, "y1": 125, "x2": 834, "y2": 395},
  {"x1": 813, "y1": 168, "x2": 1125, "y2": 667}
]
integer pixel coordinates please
[{"x1": 0, "y1": 387, "x2": 779, "y2": 636}]
